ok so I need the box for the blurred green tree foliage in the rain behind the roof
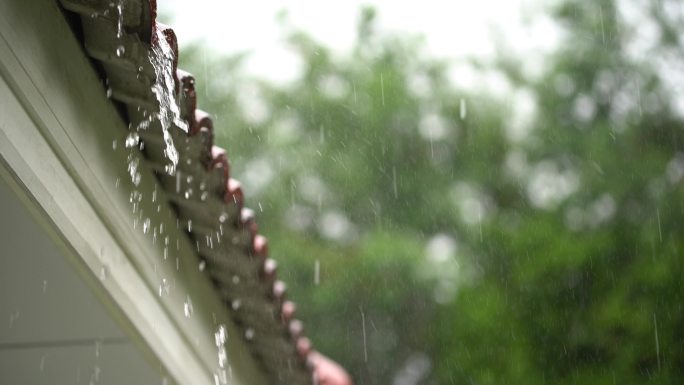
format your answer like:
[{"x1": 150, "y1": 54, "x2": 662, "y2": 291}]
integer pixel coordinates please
[{"x1": 178, "y1": 0, "x2": 684, "y2": 384}]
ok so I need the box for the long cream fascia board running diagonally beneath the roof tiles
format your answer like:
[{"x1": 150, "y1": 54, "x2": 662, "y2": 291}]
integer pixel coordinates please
[{"x1": 0, "y1": 0, "x2": 265, "y2": 384}]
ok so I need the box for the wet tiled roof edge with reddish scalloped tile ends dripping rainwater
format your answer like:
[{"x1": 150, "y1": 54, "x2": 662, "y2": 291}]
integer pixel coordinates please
[{"x1": 52, "y1": 0, "x2": 344, "y2": 384}]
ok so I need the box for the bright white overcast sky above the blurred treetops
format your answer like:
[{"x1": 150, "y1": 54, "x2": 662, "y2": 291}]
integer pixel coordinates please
[{"x1": 158, "y1": 0, "x2": 558, "y2": 81}]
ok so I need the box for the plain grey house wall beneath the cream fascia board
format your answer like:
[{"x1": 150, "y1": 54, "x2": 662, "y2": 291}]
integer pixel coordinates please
[{"x1": 0, "y1": 179, "x2": 173, "y2": 385}]
